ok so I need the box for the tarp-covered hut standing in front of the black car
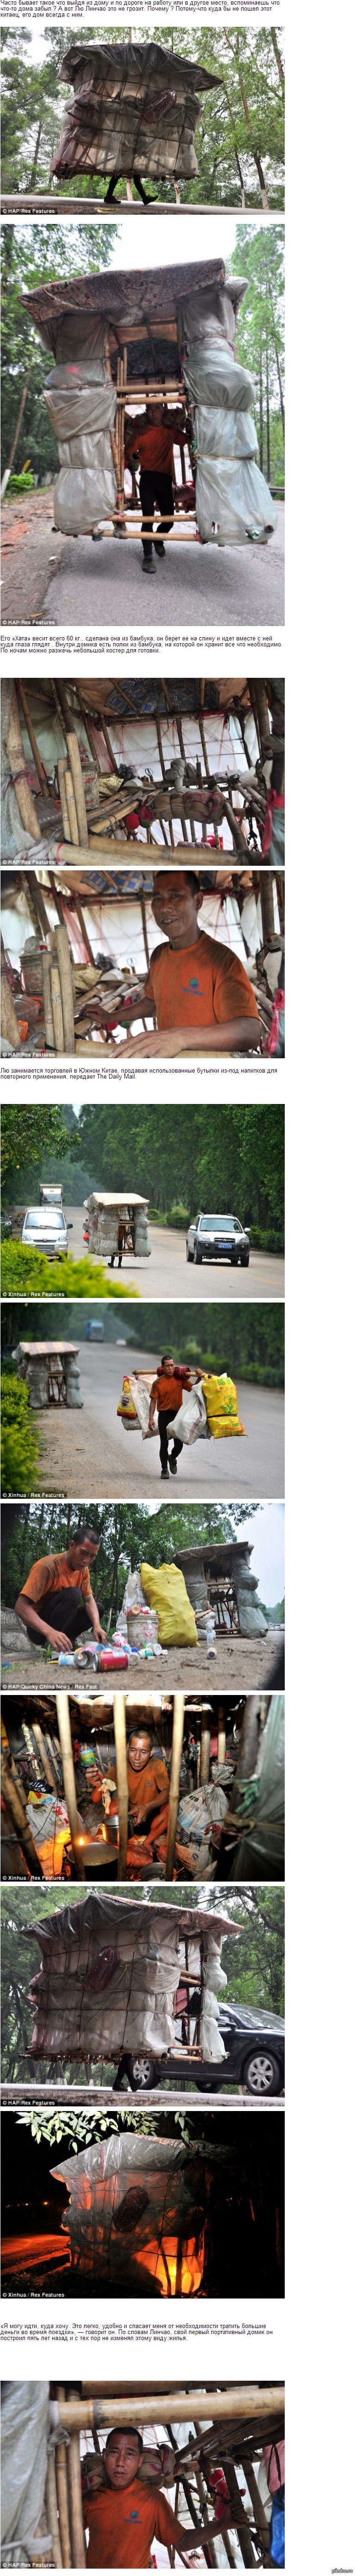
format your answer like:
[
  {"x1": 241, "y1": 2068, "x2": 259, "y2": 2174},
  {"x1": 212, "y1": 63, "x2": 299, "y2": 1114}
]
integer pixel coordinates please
[{"x1": 23, "y1": 1885, "x2": 229, "y2": 2058}]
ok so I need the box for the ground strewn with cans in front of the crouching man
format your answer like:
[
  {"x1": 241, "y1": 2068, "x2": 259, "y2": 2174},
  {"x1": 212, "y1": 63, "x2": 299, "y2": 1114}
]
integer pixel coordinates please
[{"x1": 0, "y1": 1628, "x2": 281, "y2": 1698}]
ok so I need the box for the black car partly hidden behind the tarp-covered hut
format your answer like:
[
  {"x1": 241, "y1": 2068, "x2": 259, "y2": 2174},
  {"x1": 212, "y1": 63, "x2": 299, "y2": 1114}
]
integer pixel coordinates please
[{"x1": 116, "y1": 2004, "x2": 286, "y2": 2102}]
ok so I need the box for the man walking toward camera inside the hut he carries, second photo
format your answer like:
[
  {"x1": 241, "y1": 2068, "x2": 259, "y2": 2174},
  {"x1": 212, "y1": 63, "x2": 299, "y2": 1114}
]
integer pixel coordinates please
[{"x1": 126, "y1": 402, "x2": 185, "y2": 572}]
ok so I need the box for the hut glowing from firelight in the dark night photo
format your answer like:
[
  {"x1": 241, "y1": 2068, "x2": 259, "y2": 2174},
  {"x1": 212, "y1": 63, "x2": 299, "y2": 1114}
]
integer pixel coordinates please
[{"x1": 51, "y1": 2136, "x2": 203, "y2": 2287}]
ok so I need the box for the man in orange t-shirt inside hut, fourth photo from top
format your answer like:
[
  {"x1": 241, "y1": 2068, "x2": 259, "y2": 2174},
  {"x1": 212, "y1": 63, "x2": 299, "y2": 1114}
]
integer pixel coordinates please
[{"x1": 129, "y1": 868, "x2": 260, "y2": 1056}]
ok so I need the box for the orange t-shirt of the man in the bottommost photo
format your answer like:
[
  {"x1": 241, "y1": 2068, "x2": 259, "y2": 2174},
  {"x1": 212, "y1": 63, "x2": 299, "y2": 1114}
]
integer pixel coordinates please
[{"x1": 82, "y1": 2478, "x2": 180, "y2": 2568}]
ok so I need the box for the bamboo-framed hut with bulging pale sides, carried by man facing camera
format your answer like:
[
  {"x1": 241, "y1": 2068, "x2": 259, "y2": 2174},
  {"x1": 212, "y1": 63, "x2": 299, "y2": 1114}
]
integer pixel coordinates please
[{"x1": 23, "y1": 260, "x2": 278, "y2": 546}]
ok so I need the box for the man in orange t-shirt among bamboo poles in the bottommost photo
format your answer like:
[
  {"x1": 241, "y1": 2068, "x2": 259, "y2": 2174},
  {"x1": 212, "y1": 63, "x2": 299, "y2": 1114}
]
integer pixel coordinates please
[{"x1": 82, "y1": 2424, "x2": 234, "y2": 2568}]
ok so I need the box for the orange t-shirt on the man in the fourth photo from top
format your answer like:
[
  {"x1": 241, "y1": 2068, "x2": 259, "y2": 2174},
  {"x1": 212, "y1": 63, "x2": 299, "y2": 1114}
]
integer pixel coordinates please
[{"x1": 149, "y1": 930, "x2": 257, "y2": 1028}]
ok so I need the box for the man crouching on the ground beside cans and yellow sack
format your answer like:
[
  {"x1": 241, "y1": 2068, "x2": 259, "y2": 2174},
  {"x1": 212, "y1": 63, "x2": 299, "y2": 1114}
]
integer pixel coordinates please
[{"x1": 15, "y1": 1527, "x2": 105, "y2": 1654}]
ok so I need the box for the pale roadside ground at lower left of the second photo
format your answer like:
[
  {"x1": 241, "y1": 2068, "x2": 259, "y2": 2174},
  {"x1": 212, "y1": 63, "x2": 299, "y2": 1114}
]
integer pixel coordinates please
[{"x1": 0, "y1": 492, "x2": 67, "y2": 626}]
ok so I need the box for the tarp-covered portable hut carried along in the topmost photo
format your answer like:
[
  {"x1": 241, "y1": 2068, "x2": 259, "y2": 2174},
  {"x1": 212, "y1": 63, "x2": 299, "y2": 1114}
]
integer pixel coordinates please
[{"x1": 51, "y1": 41, "x2": 219, "y2": 178}]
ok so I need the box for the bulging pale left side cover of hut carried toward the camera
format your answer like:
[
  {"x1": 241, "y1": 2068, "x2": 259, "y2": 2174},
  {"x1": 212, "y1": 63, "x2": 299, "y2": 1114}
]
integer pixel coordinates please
[{"x1": 41, "y1": 317, "x2": 116, "y2": 536}]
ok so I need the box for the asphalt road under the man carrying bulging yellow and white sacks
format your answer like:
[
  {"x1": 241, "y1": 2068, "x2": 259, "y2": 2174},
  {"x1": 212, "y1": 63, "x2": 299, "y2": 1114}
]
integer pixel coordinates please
[{"x1": 38, "y1": 1342, "x2": 283, "y2": 1502}]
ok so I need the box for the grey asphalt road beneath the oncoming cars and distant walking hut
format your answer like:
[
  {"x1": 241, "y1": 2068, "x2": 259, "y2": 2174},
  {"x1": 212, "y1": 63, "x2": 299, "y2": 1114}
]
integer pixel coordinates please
[{"x1": 64, "y1": 1203, "x2": 286, "y2": 1298}]
